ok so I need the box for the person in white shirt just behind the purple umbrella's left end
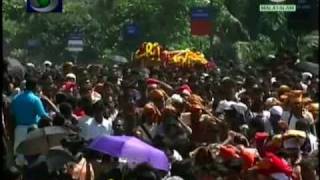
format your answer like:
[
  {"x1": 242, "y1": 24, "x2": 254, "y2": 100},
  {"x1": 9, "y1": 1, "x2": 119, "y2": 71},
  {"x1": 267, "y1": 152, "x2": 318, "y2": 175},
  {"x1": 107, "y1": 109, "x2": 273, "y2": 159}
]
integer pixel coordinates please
[{"x1": 78, "y1": 100, "x2": 117, "y2": 140}]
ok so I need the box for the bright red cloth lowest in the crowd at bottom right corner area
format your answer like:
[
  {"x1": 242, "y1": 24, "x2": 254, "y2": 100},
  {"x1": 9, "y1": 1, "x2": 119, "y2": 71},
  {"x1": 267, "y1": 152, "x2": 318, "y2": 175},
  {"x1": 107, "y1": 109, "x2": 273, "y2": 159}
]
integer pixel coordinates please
[{"x1": 258, "y1": 152, "x2": 293, "y2": 177}]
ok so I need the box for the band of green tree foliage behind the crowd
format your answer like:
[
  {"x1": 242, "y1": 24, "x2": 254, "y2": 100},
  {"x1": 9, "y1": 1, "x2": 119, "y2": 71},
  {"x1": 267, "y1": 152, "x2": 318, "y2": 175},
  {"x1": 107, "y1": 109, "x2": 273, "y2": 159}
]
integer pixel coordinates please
[{"x1": 3, "y1": 0, "x2": 318, "y2": 62}]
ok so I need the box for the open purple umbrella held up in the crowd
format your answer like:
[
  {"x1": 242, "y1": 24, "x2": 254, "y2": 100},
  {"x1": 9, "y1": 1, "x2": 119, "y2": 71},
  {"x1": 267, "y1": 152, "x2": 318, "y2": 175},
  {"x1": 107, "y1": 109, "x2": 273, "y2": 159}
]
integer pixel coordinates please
[{"x1": 89, "y1": 136, "x2": 170, "y2": 171}]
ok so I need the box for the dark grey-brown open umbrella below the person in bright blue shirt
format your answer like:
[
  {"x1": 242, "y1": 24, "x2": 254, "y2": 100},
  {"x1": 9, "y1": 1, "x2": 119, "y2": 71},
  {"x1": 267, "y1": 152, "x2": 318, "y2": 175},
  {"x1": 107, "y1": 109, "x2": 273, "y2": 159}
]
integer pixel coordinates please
[{"x1": 17, "y1": 126, "x2": 69, "y2": 155}]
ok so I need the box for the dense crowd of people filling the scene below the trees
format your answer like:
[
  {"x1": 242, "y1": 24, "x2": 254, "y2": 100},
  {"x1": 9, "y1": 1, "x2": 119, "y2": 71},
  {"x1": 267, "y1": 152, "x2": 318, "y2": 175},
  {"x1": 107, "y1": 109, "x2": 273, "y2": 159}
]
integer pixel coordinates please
[{"x1": 2, "y1": 53, "x2": 319, "y2": 180}]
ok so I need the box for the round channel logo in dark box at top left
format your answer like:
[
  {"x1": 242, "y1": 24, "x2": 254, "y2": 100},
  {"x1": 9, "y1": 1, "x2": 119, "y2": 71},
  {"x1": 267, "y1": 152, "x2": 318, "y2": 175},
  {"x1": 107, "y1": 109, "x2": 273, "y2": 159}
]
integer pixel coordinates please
[{"x1": 27, "y1": 0, "x2": 62, "y2": 13}]
